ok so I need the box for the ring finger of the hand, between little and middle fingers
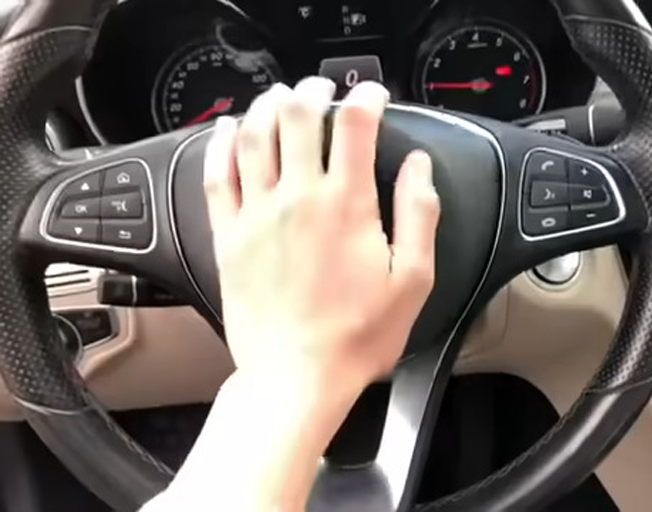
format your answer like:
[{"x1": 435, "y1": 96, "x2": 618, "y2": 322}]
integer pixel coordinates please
[{"x1": 237, "y1": 84, "x2": 292, "y2": 201}]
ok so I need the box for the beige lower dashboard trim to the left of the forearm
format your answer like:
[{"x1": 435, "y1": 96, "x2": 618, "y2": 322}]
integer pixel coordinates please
[{"x1": 0, "y1": 284, "x2": 234, "y2": 421}]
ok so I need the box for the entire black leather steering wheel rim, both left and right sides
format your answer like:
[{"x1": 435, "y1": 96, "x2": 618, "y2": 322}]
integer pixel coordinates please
[{"x1": 0, "y1": 0, "x2": 652, "y2": 512}]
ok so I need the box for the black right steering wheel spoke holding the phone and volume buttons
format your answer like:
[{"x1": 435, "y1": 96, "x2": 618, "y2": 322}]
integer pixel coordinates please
[{"x1": 476, "y1": 118, "x2": 650, "y2": 292}]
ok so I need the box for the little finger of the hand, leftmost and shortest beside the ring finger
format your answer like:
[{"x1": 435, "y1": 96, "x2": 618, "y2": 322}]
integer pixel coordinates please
[{"x1": 204, "y1": 116, "x2": 241, "y2": 233}]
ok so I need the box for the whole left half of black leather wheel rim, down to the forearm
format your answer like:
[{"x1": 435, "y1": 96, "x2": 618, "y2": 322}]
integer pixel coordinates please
[{"x1": 0, "y1": 4, "x2": 171, "y2": 510}]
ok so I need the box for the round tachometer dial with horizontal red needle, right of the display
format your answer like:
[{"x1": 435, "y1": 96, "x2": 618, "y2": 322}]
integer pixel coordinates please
[{"x1": 417, "y1": 25, "x2": 546, "y2": 121}]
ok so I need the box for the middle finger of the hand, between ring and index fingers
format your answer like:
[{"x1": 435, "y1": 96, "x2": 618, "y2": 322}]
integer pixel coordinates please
[{"x1": 279, "y1": 77, "x2": 335, "y2": 187}]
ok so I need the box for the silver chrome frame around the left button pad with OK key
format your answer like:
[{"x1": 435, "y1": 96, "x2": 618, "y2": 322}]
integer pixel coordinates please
[{"x1": 39, "y1": 158, "x2": 158, "y2": 254}]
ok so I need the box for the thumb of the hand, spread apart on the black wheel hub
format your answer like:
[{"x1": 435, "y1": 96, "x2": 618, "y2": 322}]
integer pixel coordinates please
[{"x1": 392, "y1": 151, "x2": 440, "y2": 296}]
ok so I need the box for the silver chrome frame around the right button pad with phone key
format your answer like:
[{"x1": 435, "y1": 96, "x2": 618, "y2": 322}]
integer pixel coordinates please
[{"x1": 518, "y1": 147, "x2": 627, "y2": 242}]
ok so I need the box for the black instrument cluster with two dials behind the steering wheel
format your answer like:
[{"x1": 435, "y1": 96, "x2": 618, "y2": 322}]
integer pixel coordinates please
[{"x1": 76, "y1": 0, "x2": 596, "y2": 144}]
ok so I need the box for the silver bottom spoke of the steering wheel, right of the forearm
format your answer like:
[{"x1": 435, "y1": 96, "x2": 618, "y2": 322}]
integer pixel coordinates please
[{"x1": 307, "y1": 331, "x2": 462, "y2": 512}]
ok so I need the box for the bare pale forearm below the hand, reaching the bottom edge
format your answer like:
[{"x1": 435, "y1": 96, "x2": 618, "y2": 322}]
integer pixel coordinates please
[{"x1": 144, "y1": 364, "x2": 358, "y2": 512}]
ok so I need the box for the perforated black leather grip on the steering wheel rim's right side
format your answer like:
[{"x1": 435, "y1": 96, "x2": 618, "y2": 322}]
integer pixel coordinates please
[{"x1": 565, "y1": 12, "x2": 652, "y2": 391}]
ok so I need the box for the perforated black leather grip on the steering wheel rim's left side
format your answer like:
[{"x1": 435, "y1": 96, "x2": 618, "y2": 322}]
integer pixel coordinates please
[{"x1": 0, "y1": 28, "x2": 92, "y2": 411}]
